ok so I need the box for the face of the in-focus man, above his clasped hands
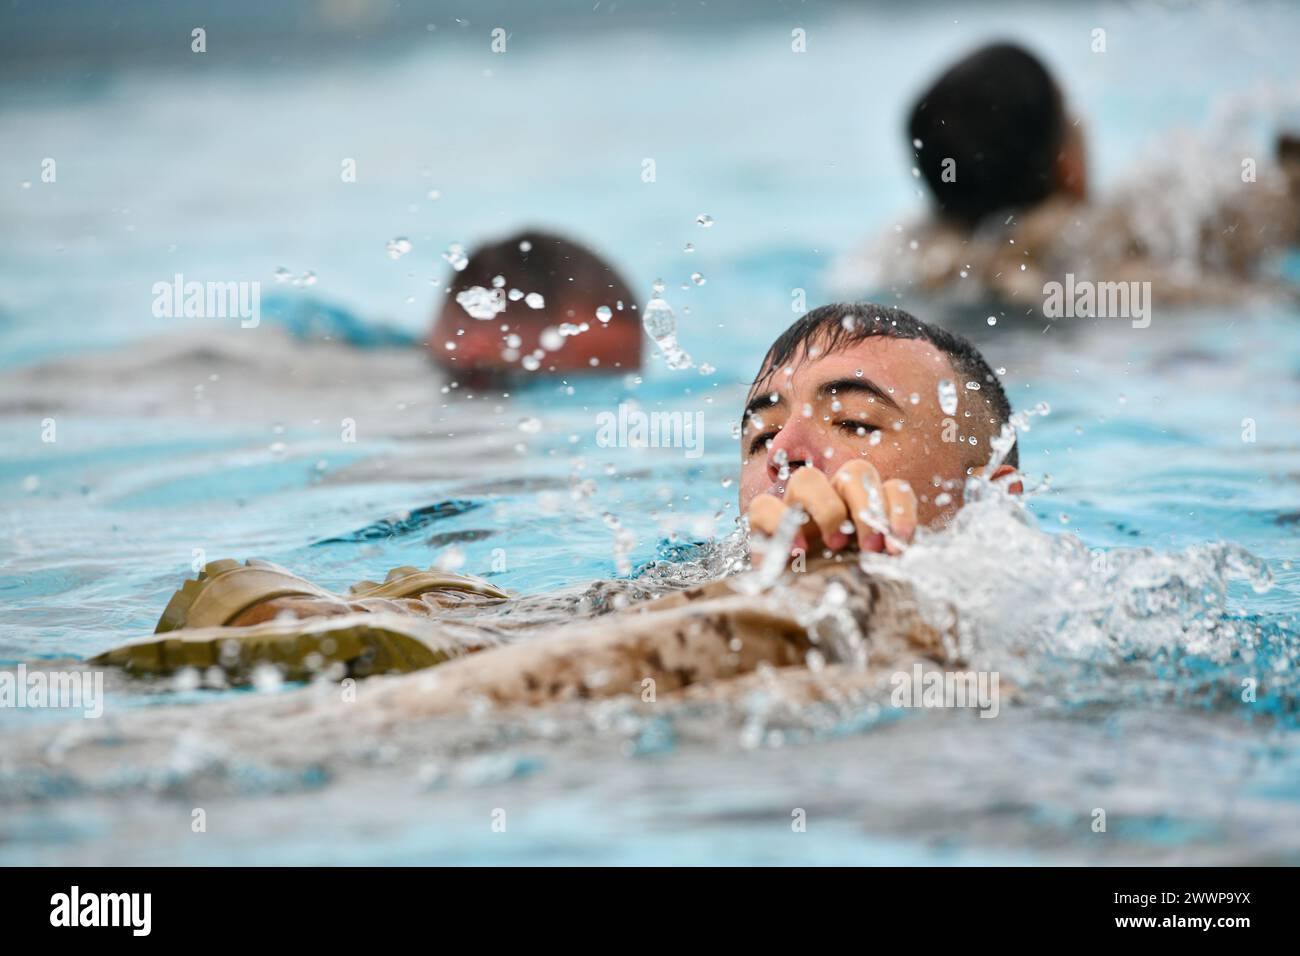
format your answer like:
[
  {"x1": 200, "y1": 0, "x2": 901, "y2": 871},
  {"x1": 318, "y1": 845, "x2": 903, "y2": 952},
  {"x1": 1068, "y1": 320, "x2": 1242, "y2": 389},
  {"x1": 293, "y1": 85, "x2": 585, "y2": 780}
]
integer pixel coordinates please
[{"x1": 740, "y1": 336, "x2": 988, "y2": 525}]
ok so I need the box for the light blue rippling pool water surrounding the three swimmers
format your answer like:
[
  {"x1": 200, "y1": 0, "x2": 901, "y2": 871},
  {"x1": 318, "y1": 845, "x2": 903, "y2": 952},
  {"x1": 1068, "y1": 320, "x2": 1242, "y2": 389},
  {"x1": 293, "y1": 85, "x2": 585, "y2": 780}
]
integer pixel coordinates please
[{"x1": 0, "y1": 4, "x2": 1300, "y2": 864}]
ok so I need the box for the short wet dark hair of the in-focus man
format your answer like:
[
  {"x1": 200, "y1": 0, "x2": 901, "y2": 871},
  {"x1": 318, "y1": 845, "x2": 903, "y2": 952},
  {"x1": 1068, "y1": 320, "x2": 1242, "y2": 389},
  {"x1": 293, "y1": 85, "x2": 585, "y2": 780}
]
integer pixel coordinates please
[{"x1": 753, "y1": 302, "x2": 1021, "y2": 468}]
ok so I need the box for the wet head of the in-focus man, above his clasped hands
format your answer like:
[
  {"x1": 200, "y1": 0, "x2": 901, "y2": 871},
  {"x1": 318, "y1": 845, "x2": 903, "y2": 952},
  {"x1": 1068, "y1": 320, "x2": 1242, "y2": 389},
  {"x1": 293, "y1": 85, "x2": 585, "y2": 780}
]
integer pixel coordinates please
[{"x1": 740, "y1": 303, "x2": 1019, "y2": 524}]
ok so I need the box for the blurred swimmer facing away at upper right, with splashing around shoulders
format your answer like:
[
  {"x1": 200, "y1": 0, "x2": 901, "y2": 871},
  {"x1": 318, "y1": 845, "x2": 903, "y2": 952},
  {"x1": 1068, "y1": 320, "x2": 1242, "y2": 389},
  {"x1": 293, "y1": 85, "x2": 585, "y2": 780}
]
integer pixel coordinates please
[{"x1": 832, "y1": 43, "x2": 1300, "y2": 308}]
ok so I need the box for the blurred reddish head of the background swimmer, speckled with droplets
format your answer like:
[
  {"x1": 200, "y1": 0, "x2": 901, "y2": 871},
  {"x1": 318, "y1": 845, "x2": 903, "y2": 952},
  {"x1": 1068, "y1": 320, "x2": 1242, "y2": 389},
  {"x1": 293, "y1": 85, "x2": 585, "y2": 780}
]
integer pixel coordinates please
[{"x1": 428, "y1": 230, "x2": 642, "y2": 382}]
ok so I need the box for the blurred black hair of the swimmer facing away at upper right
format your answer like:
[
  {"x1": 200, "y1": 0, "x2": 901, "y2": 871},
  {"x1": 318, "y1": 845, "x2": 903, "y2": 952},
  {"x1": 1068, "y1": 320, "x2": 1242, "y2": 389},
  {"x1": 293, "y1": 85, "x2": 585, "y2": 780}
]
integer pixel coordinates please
[{"x1": 907, "y1": 43, "x2": 1066, "y2": 226}]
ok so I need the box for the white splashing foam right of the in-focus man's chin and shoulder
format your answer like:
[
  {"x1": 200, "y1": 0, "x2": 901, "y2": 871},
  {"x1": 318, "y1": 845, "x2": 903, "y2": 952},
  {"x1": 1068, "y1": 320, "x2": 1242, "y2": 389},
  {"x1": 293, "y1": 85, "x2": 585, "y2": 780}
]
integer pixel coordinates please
[{"x1": 867, "y1": 484, "x2": 1296, "y2": 711}]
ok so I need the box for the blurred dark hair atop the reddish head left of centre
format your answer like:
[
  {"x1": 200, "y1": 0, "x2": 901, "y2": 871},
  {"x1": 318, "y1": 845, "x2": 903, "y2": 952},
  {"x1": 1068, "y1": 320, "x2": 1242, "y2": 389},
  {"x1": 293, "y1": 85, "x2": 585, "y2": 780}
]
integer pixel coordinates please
[{"x1": 447, "y1": 229, "x2": 640, "y2": 323}]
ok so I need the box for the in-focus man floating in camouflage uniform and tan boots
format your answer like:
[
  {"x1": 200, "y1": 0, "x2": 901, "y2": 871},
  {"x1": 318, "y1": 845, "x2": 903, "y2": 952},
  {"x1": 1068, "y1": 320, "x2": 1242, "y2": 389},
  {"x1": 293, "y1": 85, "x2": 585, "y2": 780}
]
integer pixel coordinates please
[{"x1": 92, "y1": 303, "x2": 1019, "y2": 714}]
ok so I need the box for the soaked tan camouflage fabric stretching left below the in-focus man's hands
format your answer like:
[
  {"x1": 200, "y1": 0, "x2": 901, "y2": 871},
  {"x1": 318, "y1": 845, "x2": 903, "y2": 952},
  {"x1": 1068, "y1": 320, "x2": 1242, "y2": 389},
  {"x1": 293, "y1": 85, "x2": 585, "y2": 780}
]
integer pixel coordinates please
[{"x1": 361, "y1": 567, "x2": 941, "y2": 713}]
